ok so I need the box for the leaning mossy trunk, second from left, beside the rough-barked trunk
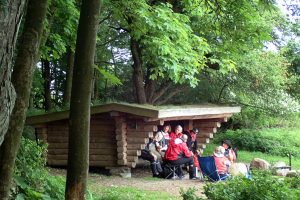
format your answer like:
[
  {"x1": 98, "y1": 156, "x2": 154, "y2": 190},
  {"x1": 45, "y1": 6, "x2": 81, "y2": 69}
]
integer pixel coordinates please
[{"x1": 0, "y1": 0, "x2": 47, "y2": 199}]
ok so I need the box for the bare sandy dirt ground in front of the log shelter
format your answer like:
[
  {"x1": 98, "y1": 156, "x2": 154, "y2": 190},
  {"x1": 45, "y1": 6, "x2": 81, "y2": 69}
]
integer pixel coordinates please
[{"x1": 50, "y1": 166, "x2": 205, "y2": 199}]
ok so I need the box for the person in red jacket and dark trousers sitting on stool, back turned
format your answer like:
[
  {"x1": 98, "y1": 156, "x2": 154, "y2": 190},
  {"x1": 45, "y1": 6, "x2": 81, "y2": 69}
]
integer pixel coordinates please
[{"x1": 165, "y1": 135, "x2": 196, "y2": 179}]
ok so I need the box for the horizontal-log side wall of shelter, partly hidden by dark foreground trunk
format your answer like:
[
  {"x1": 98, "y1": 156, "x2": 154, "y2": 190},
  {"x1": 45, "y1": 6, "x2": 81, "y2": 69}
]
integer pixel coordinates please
[{"x1": 41, "y1": 114, "x2": 117, "y2": 167}]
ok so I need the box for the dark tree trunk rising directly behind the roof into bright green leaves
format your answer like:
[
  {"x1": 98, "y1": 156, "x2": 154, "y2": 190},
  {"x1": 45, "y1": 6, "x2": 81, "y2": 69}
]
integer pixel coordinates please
[{"x1": 130, "y1": 38, "x2": 147, "y2": 104}]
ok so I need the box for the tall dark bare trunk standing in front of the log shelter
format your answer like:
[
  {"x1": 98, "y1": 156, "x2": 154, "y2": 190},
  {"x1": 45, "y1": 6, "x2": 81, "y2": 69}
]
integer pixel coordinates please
[{"x1": 65, "y1": 0, "x2": 100, "y2": 200}]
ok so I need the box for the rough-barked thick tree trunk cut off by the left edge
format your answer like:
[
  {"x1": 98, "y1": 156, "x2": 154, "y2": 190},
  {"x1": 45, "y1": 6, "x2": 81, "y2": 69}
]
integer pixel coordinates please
[{"x1": 0, "y1": 0, "x2": 25, "y2": 146}]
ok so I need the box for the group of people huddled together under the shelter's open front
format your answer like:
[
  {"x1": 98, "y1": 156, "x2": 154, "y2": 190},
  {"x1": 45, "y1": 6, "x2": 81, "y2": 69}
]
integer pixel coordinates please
[{"x1": 141, "y1": 125, "x2": 199, "y2": 180}]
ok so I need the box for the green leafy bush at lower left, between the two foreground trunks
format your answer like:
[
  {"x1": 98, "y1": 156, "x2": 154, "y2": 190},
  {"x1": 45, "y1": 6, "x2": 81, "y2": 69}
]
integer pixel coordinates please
[{"x1": 12, "y1": 137, "x2": 65, "y2": 200}]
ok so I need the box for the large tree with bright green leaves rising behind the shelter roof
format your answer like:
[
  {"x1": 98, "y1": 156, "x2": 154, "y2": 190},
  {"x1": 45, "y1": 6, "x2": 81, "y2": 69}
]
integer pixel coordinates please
[{"x1": 103, "y1": 0, "x2": 277, "y2": 104}]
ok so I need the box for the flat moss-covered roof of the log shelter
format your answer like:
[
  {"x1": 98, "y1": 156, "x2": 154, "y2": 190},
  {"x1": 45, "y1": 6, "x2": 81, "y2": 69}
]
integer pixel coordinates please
[{"x1": 26, "y1": 103, "x2": 241, "y2": 125}]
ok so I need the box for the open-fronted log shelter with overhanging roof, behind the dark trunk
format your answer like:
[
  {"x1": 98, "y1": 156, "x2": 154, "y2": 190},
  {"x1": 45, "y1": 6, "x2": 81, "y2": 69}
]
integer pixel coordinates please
[{"x1": 26, "y1": 103, "x2": 241, "y2": 168}]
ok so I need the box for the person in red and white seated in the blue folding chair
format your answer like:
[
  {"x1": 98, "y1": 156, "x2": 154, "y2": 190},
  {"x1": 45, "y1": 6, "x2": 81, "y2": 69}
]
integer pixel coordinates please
[{"x1": 213, "y1": 146, "x2": 231, "y2": 179}]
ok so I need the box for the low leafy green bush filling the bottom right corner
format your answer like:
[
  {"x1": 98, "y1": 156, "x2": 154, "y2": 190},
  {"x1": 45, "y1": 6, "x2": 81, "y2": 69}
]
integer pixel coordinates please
[{"x1": 204, "y1": 172, "x2": 300, "y2": 200}]
